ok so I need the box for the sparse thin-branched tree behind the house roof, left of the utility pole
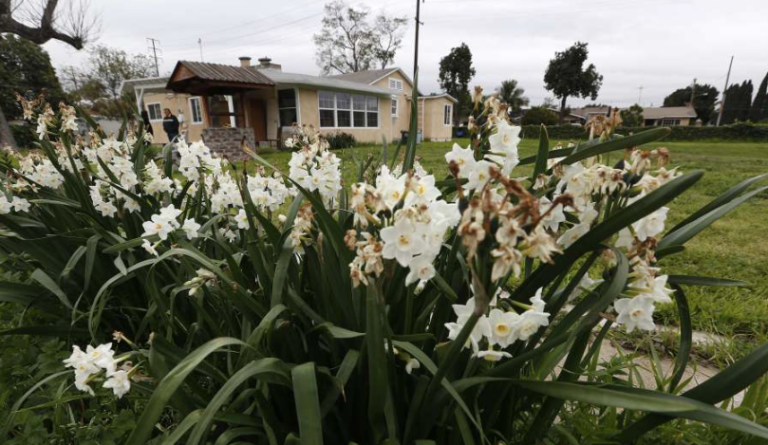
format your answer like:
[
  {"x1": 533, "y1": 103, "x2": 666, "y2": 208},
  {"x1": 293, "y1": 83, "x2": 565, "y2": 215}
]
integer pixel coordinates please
[{"x1": 313, "y1": 0, "x2": 407, "y2": 74}]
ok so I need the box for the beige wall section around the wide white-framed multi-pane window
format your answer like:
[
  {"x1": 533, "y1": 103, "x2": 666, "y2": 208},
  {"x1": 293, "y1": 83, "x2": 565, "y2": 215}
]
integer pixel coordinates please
[{"x1": 299, "y1": 88, "x2": 400, "y2": 143}]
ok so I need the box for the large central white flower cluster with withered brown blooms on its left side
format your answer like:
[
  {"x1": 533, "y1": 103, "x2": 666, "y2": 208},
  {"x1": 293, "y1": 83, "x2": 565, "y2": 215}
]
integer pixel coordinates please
[{"x1": 347, "y1": 166, "x2": 460, "y2": 285}]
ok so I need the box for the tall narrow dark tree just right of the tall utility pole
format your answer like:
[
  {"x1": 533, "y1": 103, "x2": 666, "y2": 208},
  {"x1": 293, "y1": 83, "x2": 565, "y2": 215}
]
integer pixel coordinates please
[{"x1": 437, "y1": 43, "x2": 475, "y2": 125}]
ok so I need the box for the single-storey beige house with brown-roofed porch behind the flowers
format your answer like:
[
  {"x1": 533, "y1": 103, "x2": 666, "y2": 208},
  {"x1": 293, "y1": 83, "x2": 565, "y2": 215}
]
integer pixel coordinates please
[{"x1": 121, "y1": 57, "x2": 457, "y2": 156}]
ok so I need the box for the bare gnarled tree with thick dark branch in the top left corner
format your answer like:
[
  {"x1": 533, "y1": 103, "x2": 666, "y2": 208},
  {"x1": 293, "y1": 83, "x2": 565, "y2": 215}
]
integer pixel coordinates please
[{"x1": 0, "y1": 0, "x2": 99, "y2": 148}]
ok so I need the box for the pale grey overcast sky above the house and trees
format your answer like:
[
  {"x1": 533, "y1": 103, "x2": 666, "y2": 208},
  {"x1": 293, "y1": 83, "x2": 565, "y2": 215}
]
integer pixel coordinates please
[{"x1": 45, "y1": 0, "x2": 768, "y2": 106}]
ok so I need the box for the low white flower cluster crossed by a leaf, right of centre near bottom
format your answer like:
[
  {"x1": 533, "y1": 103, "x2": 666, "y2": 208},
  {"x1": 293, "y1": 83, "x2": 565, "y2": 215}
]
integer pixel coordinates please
[{"x1": 445, "y1": 289, "x2": 550, "y2": 361}]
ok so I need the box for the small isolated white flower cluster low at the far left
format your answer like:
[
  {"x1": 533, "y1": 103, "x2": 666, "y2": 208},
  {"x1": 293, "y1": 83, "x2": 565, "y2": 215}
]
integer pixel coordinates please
[{"x1": 64, "y1": 343, "x2": 131, "y2": 398}]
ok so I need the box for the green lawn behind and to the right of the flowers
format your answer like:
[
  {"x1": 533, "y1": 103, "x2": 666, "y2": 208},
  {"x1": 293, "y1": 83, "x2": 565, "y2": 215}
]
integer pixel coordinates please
[{"x1": 256, "y1": 140, "x2": 768, "y2": 366}]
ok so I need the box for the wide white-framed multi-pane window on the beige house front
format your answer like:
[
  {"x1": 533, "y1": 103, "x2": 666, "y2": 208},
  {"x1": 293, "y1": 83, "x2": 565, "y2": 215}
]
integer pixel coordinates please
[{"x1": 318, "y1": 91, "x2": 379, "y2": 128}]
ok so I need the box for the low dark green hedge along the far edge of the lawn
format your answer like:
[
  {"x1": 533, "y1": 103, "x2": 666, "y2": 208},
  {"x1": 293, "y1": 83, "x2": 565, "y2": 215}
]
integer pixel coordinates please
[{"x1": 453, "y1": 123, "x2": 768, "y2": 142}]
